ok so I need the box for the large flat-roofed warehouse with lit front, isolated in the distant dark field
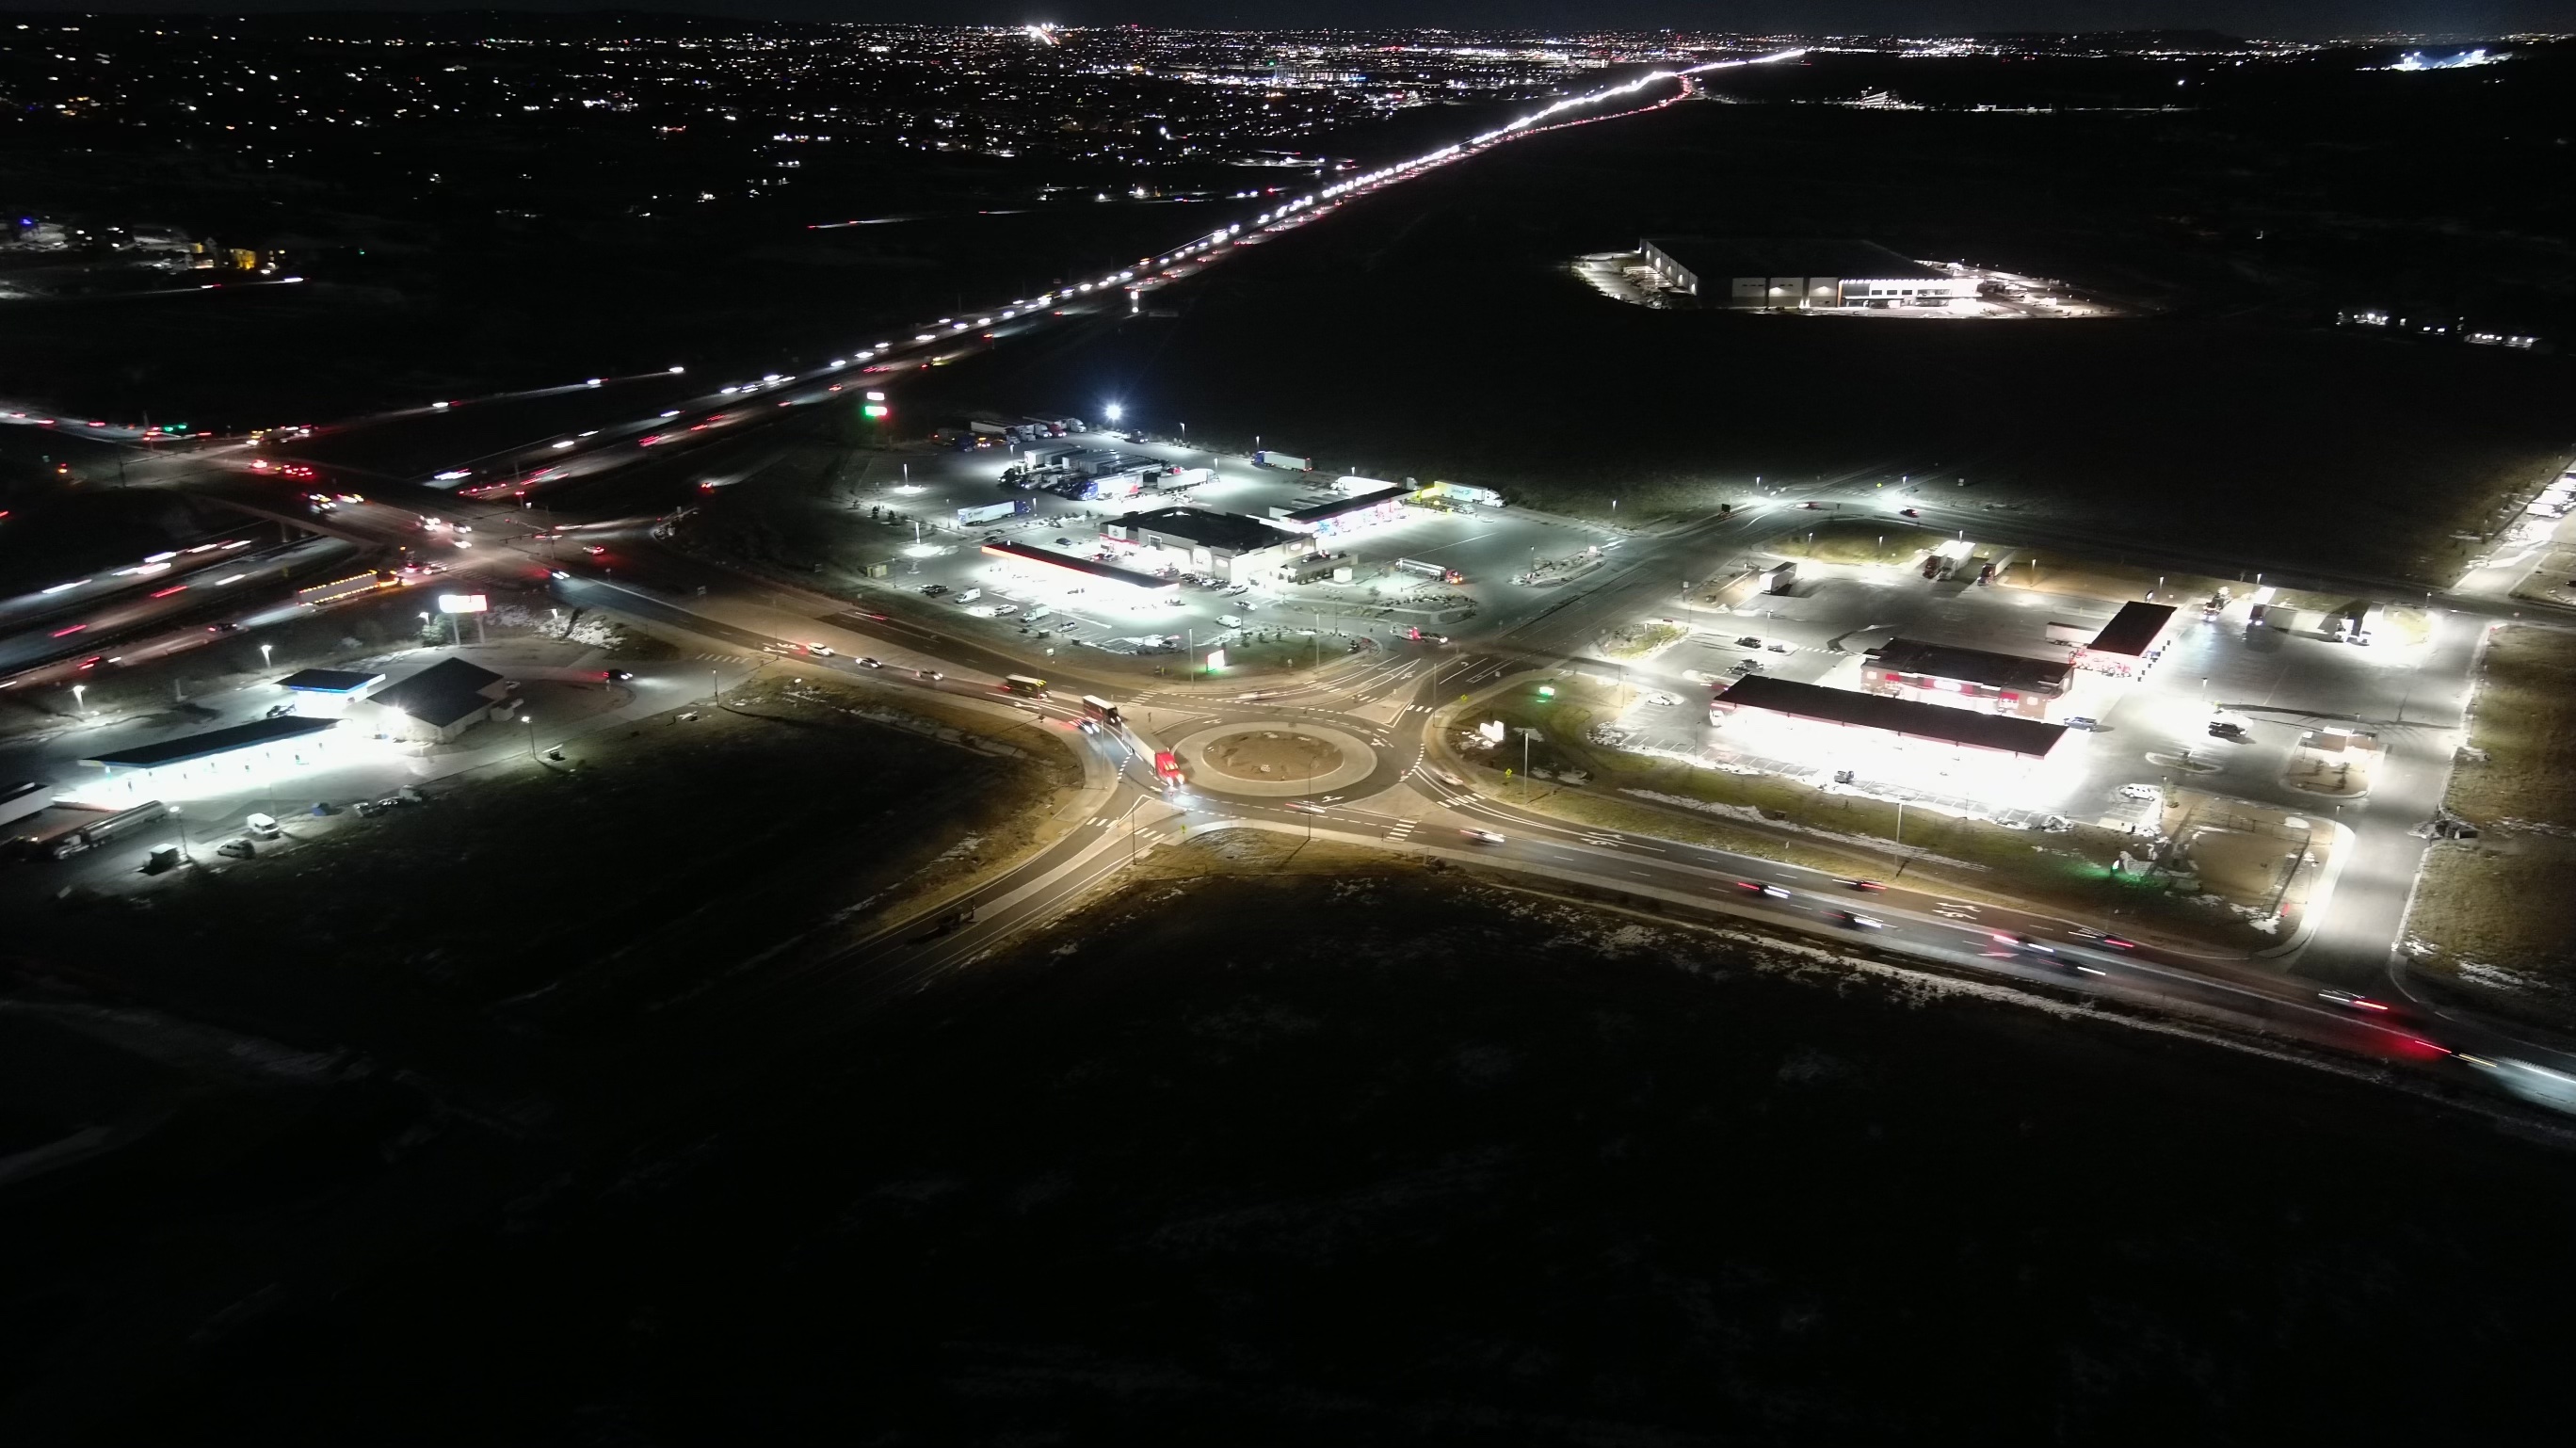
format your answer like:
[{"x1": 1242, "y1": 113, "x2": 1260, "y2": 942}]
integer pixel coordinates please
[{"x1": 1635, "y1": 237, "x2": 1976, "y2": 312}]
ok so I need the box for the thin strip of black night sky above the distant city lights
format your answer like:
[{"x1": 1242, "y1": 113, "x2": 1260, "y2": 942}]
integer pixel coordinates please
[{"x1": 8, "y1": 0, "x2": 2576, "y2": 36}]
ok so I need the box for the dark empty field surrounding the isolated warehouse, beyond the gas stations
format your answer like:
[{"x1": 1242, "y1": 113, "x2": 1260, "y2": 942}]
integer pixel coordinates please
[{"x1": 917, "y1": 80, "x2": 2576, "y2": 582}]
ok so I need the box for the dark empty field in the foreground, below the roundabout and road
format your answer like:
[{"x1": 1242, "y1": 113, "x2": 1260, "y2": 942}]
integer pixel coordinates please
[{"x1": 65, "y1": 847, "x2": 2576, "y2": 1443}]
